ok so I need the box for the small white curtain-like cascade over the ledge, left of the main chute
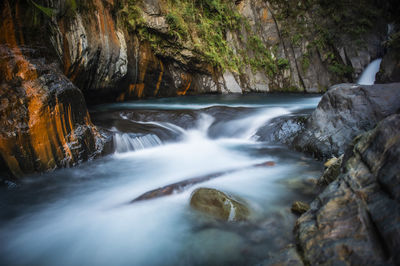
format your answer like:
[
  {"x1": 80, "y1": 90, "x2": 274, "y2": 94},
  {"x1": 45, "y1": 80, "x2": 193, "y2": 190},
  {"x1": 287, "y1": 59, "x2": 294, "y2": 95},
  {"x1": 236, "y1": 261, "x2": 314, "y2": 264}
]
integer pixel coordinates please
[{"x1": 113, "y1": 133, "x2": 162, "y2": 153}]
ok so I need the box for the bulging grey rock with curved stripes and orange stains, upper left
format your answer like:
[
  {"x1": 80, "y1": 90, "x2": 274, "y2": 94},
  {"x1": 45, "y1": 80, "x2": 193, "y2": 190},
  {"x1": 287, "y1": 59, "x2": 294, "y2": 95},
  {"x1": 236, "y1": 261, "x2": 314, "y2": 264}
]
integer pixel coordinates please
[{"x1": 49, "y1": 0, "x2": 128, "y2": 100}]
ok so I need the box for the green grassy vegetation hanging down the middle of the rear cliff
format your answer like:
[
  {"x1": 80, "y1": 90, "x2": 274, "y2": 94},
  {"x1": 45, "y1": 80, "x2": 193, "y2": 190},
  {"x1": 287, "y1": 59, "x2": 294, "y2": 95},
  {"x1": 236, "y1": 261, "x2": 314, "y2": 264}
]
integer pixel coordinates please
[{"x1": 120, "y1": 0, "x2": 289, "y2": 76}]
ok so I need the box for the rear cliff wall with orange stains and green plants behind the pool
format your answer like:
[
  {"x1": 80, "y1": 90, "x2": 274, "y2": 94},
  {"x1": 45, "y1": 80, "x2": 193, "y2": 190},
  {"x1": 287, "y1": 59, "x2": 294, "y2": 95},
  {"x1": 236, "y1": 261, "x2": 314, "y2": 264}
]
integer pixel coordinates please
[{"x1": 2, "y1": 0, "x2": 396, "y2": 101}]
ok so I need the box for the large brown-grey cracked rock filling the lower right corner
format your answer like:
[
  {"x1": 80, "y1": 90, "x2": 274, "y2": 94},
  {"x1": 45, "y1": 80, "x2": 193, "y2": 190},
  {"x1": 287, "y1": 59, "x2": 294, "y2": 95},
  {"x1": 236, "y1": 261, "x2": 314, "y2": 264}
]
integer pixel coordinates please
[{"x1": 295, "y1": 114, "x2": 400, "y2": 265}]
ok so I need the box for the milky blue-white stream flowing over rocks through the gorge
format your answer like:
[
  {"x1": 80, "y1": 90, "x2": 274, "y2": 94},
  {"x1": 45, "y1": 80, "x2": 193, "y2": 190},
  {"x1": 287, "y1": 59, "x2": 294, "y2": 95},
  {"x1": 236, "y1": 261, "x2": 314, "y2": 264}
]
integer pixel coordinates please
[{"x1": 0, "y1": 94, "x2": 322, "y2": 266}]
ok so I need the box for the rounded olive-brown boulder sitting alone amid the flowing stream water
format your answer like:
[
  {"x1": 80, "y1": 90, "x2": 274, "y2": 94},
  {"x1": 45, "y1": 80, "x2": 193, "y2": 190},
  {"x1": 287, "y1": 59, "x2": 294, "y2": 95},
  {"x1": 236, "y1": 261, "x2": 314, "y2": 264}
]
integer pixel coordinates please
[{"x1": 190, "y1": 188, "x2": 250, "y2": 222}]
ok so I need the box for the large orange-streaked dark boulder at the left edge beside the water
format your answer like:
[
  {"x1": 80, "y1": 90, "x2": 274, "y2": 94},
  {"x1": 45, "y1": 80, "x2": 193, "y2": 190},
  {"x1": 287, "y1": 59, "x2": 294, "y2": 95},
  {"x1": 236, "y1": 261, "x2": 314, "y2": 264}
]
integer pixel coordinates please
[{"x1": 0, "y1": 1, "x2": 102, "y2": 178}]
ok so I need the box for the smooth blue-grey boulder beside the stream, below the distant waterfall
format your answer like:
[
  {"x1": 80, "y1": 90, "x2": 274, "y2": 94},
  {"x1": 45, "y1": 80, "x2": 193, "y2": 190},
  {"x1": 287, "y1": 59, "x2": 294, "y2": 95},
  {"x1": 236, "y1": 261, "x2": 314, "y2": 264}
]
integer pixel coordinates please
[{"x1": 293, "y1": 83, "x2": 400, "y2": 158}]
